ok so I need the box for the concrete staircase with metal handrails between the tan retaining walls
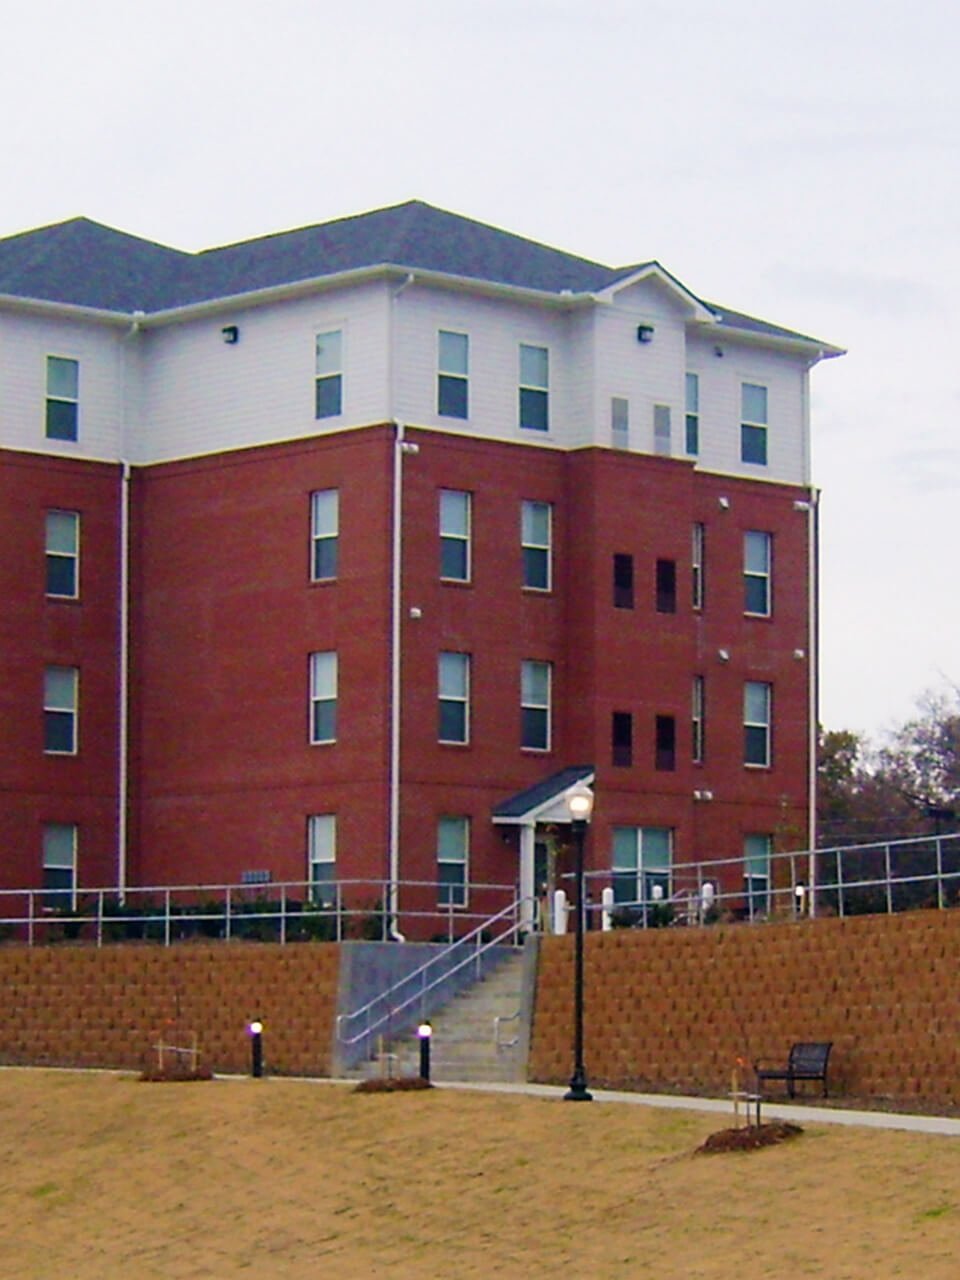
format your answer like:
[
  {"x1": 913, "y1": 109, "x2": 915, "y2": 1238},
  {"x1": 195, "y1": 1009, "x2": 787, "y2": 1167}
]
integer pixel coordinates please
[{"x1": 351, "y1": 951, "x2": 529, "y2": 1082}]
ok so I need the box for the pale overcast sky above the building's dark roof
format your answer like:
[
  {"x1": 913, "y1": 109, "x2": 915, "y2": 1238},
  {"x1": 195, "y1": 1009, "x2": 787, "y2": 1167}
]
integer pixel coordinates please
[{"x1": 0, "y1": 0, "x2": 960, "y2": 737}]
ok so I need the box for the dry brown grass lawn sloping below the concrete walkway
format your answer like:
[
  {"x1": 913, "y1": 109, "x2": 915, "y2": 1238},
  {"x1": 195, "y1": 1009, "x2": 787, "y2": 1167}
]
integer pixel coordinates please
[{"x1": 0, "y1": 1070, "x2": 960, "y2": 1280}]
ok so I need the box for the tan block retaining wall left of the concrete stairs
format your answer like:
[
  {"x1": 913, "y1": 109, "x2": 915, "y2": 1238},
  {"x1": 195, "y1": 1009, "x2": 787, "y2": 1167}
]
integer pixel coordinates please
[{"x1": 0, "y1": 943, "x2": 339, "y2": 1075}]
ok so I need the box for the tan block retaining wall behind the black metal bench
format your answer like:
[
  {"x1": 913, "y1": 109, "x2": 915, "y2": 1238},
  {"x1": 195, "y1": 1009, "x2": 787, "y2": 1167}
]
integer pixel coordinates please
[{"x1": 529, "y1": 911, "x2": 960, "y2": 1105}]
